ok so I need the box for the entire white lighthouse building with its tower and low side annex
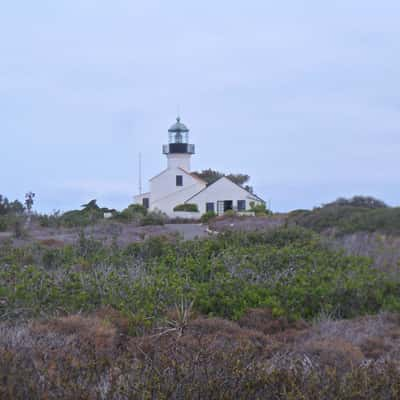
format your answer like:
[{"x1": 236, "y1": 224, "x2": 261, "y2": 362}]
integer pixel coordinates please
[{"x1": 135, "y1": 117, "x2": 264, "y2": 218}]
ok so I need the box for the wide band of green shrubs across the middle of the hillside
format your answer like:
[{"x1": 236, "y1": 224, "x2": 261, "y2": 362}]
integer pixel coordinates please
[{"x1": 0, "y1": 227, "x2": 400, "y2": 321}]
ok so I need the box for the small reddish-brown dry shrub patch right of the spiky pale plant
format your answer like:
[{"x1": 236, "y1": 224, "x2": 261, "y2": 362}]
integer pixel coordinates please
[{"x1": 239, "y1": 308, "x2": 308, "y2": 335}]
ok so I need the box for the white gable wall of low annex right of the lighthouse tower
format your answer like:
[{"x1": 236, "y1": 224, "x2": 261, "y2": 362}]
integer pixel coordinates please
[{"x1": 187, "y1": 177, "x2": 261, "y2": 215}]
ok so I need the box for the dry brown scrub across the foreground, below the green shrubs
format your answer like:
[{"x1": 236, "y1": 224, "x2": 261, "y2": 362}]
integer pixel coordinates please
[{"x1": 0, "y1": 307, "x2": 400, "y2": 399}]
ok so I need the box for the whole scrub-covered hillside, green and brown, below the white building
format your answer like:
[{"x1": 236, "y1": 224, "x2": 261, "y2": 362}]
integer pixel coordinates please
[{"x1": 0, "y1": 195, "x2": 400, "y2": 400}]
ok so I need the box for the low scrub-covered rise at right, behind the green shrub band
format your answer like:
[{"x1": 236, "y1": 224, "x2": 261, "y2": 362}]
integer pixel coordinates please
[{"x1": 210, "y1": 196, "x2": 400, "y2": 271}]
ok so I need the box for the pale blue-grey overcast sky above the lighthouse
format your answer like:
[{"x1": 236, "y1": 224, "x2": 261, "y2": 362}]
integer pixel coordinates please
[{"x1": 0, "y1": 0, "x2": 400, "y2": 211}]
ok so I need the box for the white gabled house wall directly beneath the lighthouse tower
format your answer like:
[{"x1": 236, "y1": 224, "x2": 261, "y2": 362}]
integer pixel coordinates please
[{"x1": 150, "y1": 168, "x2": 206, "y2": 217}]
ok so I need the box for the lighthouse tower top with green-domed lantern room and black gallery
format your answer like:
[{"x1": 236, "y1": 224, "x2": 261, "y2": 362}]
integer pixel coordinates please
[{"x1": 163, "y1": 117, "x2": 194, "y2": 172}]
